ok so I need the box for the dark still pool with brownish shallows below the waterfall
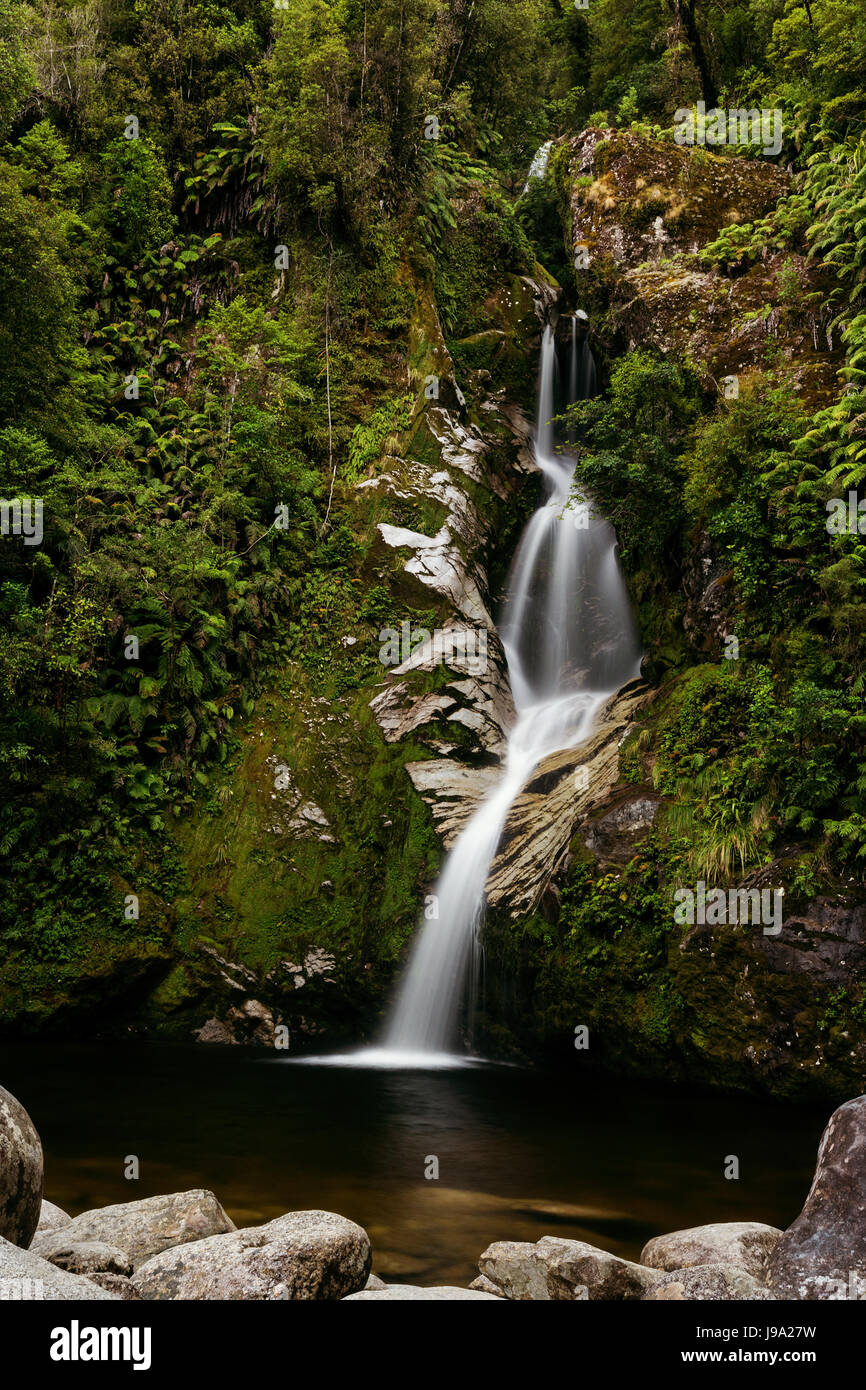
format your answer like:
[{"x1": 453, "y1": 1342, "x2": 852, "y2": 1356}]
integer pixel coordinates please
[{"x1": 0, "y1": 1041, "x2": 833, "y2": 1283}]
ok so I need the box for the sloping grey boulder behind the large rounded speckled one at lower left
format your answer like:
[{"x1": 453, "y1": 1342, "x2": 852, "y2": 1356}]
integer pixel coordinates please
[{"x1": 54, "y1": 1188, "x2": 235, "y2": 1269}]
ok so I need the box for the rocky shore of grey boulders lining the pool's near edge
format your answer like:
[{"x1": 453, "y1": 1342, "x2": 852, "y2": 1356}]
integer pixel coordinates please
[{"x1": 0, "y1": 1090, "x2": 866, "y2": 1302}]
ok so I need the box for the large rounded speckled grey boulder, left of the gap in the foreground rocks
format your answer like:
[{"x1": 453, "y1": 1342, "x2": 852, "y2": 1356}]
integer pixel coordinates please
[{"x1": 132, "y1": 1211, "x2": 369, "y2": 1300}]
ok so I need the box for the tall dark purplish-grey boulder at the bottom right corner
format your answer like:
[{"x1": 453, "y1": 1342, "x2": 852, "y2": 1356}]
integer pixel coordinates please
[{"x1": 767, "y1": 1095, "x2": 866, "y2": 1300}]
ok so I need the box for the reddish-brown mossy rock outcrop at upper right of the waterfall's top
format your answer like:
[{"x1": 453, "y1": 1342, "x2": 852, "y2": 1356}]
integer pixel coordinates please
[{"x1": 567, "y1": 128, "x2": 834, "y2": 396}]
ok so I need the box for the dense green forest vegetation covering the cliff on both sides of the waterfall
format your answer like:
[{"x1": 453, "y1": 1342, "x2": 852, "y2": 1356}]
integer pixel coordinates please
[{"x1": 0, "y1": 0, "x2": 866, "y2": 1084}]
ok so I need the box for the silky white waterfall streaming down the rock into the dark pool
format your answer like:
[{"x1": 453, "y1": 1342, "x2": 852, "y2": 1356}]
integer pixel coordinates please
[{"x1": 377, "y1": 314, "x2": 641, "y2": 1065}]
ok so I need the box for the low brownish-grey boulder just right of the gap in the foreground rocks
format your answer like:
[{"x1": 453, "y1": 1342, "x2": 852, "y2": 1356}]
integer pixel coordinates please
[{"x1": 478, "y1": 1236, "x2": 662, "y2": 1301}]
